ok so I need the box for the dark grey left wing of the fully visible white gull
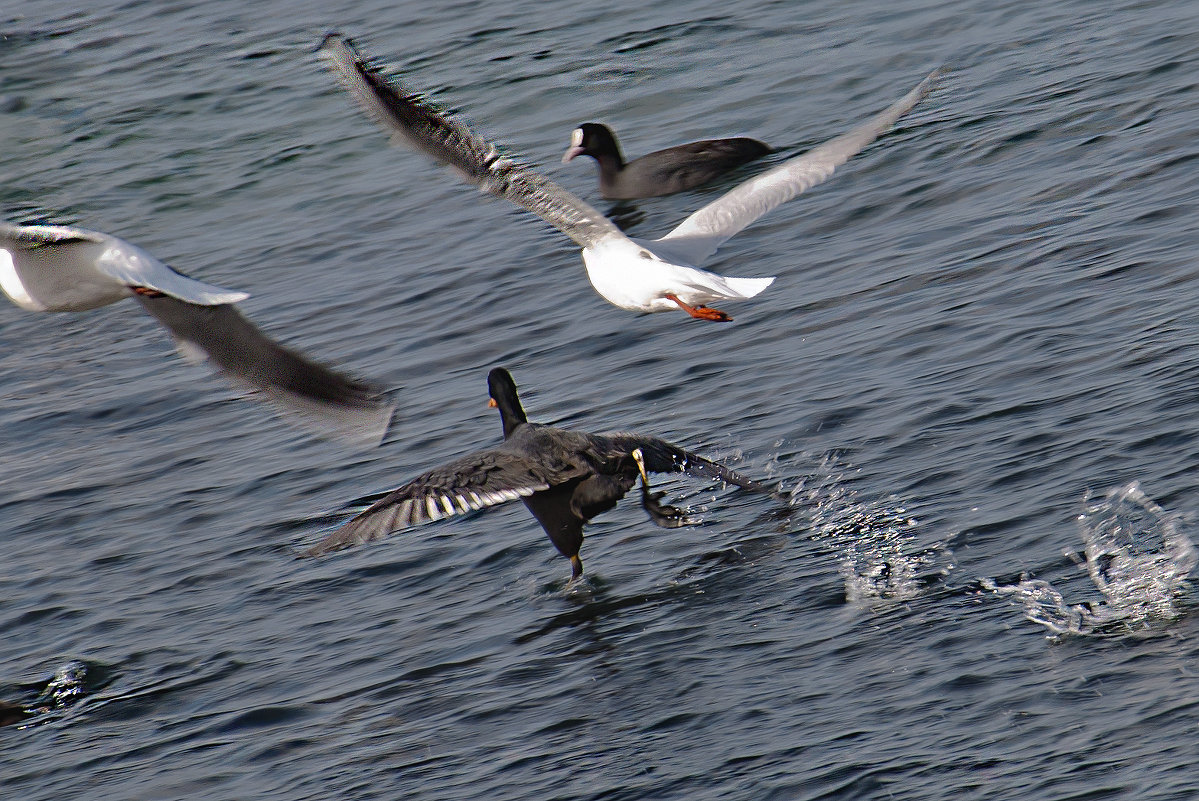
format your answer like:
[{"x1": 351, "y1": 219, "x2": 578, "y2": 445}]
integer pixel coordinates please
[{"x1": 319, "y1": 34, "x2": 623, "y2": 247}]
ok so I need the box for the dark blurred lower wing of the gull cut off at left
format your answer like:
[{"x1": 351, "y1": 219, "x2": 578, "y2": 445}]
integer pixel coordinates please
[{"x1": 135, "y1": 294, "x2": 394, "y2": 444}]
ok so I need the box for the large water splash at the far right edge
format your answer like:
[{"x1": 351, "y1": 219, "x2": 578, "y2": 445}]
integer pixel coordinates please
[{"x1": 982, "y1": 481, "x2": 1199, "y2": 637}]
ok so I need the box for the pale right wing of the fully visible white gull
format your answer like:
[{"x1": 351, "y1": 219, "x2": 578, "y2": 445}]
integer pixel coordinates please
[{"x1": 651, "y1": 70, "x2": 941, "y2": 266}]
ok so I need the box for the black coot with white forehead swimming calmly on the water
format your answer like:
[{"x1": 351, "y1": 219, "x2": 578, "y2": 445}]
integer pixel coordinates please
[{"x1": 562, "y1": 122, "x2": 772, "y2": 200}]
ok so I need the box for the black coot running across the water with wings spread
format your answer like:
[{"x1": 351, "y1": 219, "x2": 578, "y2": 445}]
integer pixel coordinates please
[{"x1": 305, "y1": 367, "x2": 771, "y2": 579}]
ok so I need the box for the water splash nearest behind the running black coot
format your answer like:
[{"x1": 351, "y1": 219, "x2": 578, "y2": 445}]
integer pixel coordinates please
[{"x1": 790, "y1": 457, "x2": 953, "y2": 603}]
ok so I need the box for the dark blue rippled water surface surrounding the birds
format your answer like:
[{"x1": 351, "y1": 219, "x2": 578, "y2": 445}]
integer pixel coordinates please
[{"x1": 0, "y1": 0, "x2": 1199, "y2": 801}]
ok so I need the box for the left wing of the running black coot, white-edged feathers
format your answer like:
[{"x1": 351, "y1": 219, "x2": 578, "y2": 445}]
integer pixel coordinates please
[{"x1": 303, "y1": 447, "x2": 549, "y2": 556}]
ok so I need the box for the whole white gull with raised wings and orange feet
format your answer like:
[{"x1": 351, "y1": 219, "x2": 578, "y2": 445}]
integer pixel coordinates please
[{"x1": 319, "y1": 34, "x2": 939, "y2": 323}]
